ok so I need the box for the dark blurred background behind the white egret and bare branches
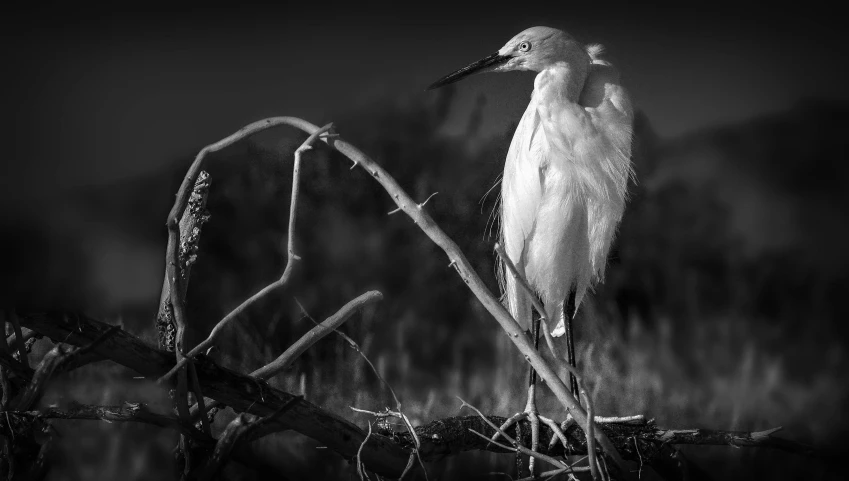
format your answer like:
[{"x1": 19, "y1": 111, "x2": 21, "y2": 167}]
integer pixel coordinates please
[{"x1": 0, "y1": 2, "x2": 849, "y2": 479}]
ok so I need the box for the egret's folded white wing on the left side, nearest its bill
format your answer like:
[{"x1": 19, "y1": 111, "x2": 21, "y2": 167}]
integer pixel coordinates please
[{"x1": 501, "y1": 93, "x2": 543, "y2": 265}]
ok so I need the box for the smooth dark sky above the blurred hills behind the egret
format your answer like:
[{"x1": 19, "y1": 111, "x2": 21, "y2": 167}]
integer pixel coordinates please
[{"x1": 0, "y1": 2, "x2": 849, "y2": 197}]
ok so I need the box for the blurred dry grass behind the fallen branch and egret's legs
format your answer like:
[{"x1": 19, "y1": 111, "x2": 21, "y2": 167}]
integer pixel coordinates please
[{"x1": 31, "y1": 290, "x2": 849, "y2": 481}]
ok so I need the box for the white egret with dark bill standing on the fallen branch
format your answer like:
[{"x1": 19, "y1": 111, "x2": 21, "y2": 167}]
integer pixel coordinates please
[{"x1": 428, "y1": 27, "x2": 633, "y2": 474}]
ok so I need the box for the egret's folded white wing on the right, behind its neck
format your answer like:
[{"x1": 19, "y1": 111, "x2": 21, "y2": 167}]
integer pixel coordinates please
[{"x1": 580, "y1": 56, "x2": 634, "y2": 278}]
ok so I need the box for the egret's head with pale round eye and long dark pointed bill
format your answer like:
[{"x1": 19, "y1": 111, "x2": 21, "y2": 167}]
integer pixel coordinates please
[{"x1": 427, "y1": 27, "x2": 590, "y2": 90}]
